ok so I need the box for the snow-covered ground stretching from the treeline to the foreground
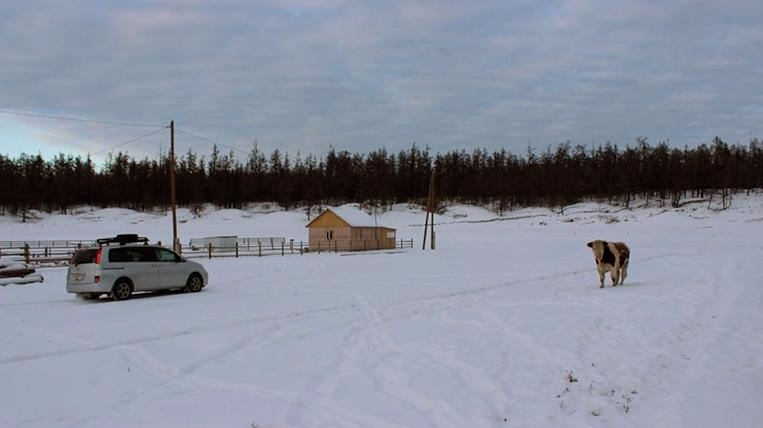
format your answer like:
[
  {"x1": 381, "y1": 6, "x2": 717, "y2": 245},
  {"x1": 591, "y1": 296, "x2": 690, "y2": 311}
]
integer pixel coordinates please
[{"x1": 0, "y1": 195, "x2": 763, "y2": 428}]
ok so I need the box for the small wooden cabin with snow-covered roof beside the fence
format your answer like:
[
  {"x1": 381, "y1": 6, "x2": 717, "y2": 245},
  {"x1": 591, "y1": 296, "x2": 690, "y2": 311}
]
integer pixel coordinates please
[{"x1": 305, "y1": 207, "x2": 396, "y2": 251}]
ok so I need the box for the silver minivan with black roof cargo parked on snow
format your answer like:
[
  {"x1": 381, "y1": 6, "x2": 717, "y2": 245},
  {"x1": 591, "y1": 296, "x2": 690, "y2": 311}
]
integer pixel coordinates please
[{"x1": 66, "y1": 234, "x2": 209, "y2": 300}]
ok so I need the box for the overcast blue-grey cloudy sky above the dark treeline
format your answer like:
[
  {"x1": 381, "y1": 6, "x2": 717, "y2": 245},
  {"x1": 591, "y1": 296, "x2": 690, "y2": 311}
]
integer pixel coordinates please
[{"x1": 0, "y1": 0, "x2": 763, "y2": 166}]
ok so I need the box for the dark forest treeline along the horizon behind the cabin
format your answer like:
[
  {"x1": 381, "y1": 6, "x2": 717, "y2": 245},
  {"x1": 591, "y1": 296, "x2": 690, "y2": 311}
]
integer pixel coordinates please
[{"x1": 0, "y1": 137, "x2": 763, "y2": 214}]
